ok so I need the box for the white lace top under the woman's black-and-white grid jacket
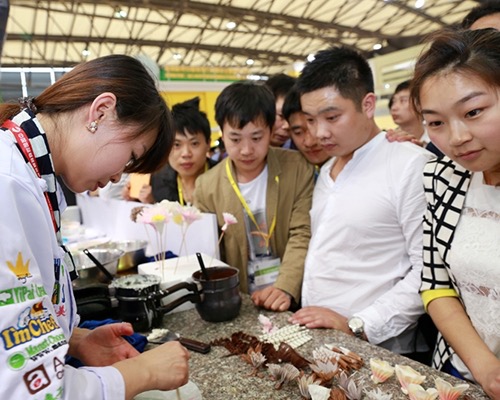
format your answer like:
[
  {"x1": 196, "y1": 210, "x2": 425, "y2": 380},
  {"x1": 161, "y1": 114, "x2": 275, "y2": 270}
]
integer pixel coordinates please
[{"x1": 449, "y1": 173, "x2": 500, "y2": 380}]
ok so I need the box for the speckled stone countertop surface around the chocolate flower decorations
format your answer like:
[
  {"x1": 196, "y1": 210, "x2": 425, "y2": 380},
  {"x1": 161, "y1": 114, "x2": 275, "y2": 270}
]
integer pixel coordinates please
[{"x1": 153, "y1": 295, "x2": 488, "y2": 400}]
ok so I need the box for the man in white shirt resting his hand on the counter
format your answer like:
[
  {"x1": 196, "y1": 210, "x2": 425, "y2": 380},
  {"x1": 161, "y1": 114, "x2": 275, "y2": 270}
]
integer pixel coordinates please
[{"x1": 291, "y1": 47, "x2": 432, "y2": 355}]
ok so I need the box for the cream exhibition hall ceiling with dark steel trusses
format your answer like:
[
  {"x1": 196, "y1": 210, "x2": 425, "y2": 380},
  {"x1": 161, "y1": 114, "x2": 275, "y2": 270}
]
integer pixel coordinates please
[{"x1": 1, "y1": 0, "x2": 478, "y2": 74}]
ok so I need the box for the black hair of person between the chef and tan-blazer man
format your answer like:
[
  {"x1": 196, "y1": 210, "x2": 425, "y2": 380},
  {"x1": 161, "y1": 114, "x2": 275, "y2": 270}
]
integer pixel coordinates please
[{"x1": 172, "y1": 97, "x2": 212, "y2": 143}]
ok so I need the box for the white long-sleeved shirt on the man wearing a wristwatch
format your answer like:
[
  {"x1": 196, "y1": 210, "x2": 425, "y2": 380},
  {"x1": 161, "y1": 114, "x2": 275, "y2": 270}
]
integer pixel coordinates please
[{"x1": 302, "y1": 132, "x2": 432, "y2": 353}]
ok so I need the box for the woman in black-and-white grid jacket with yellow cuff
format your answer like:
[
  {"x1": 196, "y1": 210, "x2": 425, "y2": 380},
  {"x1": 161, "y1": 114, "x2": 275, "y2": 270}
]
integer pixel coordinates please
[{"x1": 411, "y1": 30, "x2": 500, "y2": 399}]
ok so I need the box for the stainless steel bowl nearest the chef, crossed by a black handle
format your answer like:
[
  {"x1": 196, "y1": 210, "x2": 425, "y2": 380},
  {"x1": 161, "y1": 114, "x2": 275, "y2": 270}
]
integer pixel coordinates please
[{"x1": 71, "y1": 248, "x2": 123, "y2": 283}]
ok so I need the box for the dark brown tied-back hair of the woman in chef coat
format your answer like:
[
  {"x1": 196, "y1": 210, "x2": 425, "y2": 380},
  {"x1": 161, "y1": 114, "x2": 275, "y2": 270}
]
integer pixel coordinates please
[{"x1": 0, "y1": 55, "x2": 174, "y2": 173}]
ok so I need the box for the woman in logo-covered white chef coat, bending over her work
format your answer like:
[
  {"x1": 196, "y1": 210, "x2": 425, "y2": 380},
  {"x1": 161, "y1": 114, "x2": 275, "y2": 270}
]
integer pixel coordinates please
[{"x1": 0, "y1": 55, "x2": 189, "y2": 399}]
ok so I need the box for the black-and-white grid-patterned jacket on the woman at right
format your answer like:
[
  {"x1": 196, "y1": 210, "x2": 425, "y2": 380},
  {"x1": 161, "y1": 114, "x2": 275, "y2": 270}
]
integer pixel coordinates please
[{"x1": 420, "y1": 157, "x2": 471, "y2": 369}]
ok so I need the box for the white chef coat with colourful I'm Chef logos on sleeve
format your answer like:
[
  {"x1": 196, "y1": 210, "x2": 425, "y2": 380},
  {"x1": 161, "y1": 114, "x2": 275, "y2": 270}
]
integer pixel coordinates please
[{"x1": 0, "y1": 112, "x2": 125, "y2": 400}]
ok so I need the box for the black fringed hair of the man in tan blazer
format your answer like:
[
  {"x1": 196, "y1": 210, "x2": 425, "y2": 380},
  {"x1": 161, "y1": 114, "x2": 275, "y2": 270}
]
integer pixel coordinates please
[{"x1": 215, "y1": 80, "x2": 276, "y2": 129}]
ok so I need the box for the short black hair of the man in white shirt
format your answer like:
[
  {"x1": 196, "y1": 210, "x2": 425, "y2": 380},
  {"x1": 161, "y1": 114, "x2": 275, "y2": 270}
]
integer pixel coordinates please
[{"x1": 297, "y1": 46, "x2": 374, "y2": 109}]
